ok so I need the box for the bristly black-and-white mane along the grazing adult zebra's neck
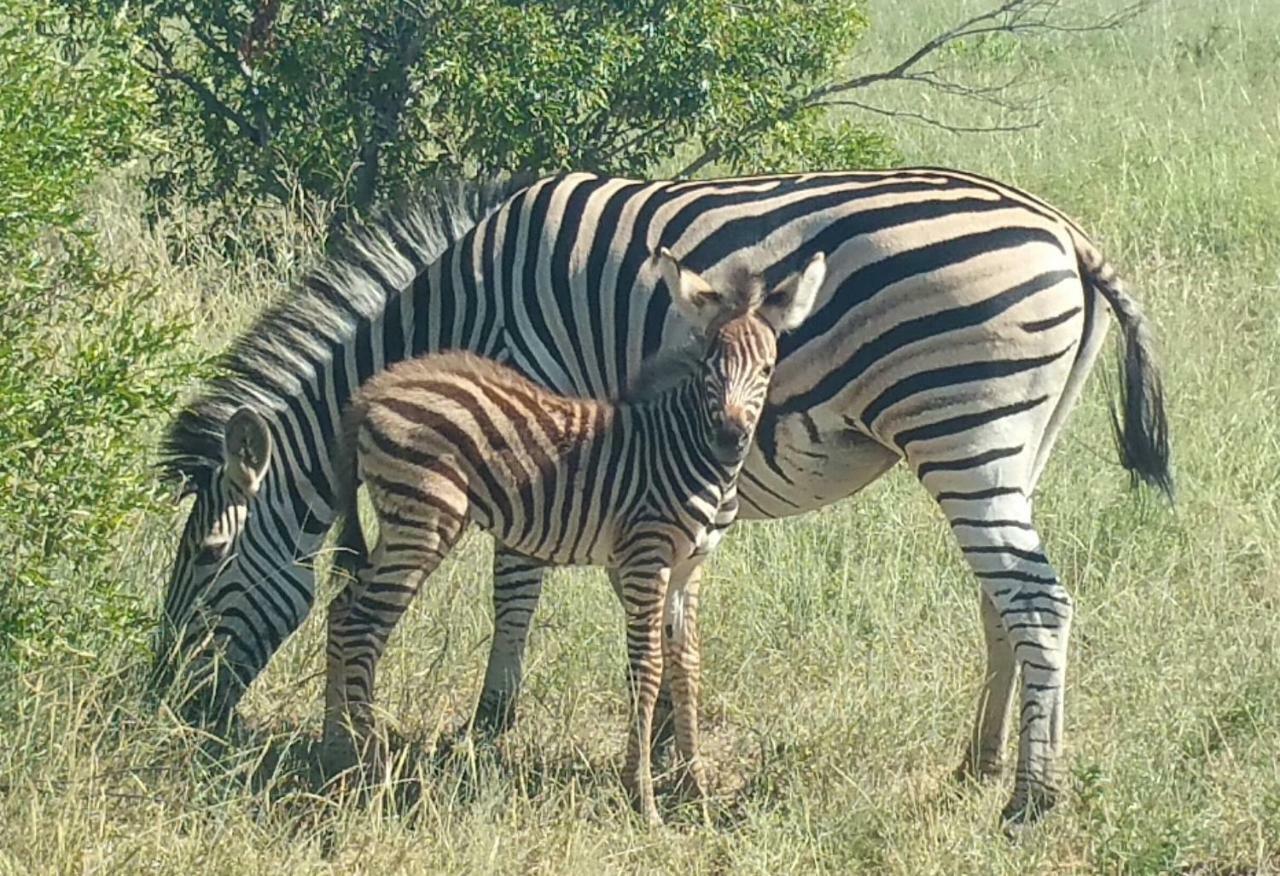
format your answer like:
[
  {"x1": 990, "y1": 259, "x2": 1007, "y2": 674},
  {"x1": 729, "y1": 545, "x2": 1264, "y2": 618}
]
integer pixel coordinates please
[{"x1": 159, "y1": 171, "x2": 531, "y2": 482}]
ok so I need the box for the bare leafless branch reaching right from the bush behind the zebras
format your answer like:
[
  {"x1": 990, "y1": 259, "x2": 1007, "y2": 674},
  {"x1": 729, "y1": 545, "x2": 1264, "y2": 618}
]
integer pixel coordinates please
[{"x1": 680, "y1": 0, "x2": 1153, "y2": 175}]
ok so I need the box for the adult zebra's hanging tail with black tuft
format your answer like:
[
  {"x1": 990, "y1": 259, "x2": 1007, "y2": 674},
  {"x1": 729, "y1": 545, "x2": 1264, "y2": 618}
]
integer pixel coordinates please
[{"x1": 1082, "y1": 259, "x2": 1174, "y2": 501}]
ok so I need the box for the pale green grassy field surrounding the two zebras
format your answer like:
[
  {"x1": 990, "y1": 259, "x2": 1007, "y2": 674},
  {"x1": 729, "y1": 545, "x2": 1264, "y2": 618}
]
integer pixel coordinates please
[{"x1": 0, "y1": 0, "x2": 1280, "y2": 873}]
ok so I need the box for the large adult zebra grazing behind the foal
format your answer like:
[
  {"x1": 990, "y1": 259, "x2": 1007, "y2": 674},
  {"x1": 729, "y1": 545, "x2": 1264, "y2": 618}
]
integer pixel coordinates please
[{"x1": 159, "y1": 168, "x2": 1171, "y2": 818}]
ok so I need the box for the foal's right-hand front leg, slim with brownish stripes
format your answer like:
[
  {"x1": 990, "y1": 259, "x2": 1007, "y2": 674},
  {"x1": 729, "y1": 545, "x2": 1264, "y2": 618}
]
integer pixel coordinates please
[{"x1": 662, "y1": 558, "x2": 707, "y2": 802}]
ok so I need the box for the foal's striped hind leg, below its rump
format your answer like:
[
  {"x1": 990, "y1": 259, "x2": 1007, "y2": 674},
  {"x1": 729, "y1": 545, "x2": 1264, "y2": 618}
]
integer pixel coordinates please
[{"x1": 324, "y1": 511, "x2": 463, "y2": 766}]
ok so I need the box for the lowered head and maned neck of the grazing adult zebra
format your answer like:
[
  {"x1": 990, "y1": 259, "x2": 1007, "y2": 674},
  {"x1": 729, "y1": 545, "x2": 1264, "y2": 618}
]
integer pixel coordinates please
[{"x1": 154, "y1": 174, "x2": 524, "y2": 722}]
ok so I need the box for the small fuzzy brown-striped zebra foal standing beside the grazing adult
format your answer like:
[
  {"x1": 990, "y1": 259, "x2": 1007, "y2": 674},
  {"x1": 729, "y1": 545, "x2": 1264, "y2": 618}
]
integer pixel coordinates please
[{"x1": 316, "y1": 250, "x2": 826, "y2": 823}]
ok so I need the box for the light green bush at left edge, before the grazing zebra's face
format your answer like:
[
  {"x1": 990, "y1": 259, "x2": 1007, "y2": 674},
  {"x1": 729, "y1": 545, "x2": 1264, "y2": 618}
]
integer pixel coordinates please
[{"x1": 0, "y1": 0, "x2": 194, "y2": 661}]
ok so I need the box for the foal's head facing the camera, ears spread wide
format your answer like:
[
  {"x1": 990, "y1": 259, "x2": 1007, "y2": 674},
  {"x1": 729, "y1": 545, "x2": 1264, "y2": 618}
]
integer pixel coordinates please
[{"x1": 655, "y1": 247, "x2": 827, "y2": 466}]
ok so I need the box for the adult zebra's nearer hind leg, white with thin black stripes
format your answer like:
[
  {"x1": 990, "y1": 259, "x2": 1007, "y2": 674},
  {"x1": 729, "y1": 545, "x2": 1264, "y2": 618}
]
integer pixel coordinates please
[{"x1": 942, "y1": 489, "x2": 1071, "y2": 823}]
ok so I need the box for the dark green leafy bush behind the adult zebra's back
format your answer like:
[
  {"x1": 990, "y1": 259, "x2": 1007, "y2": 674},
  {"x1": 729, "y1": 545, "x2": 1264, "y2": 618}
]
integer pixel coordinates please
[{"x1": 64, "y1": 0, "x2": 886, "y2": 214}]
